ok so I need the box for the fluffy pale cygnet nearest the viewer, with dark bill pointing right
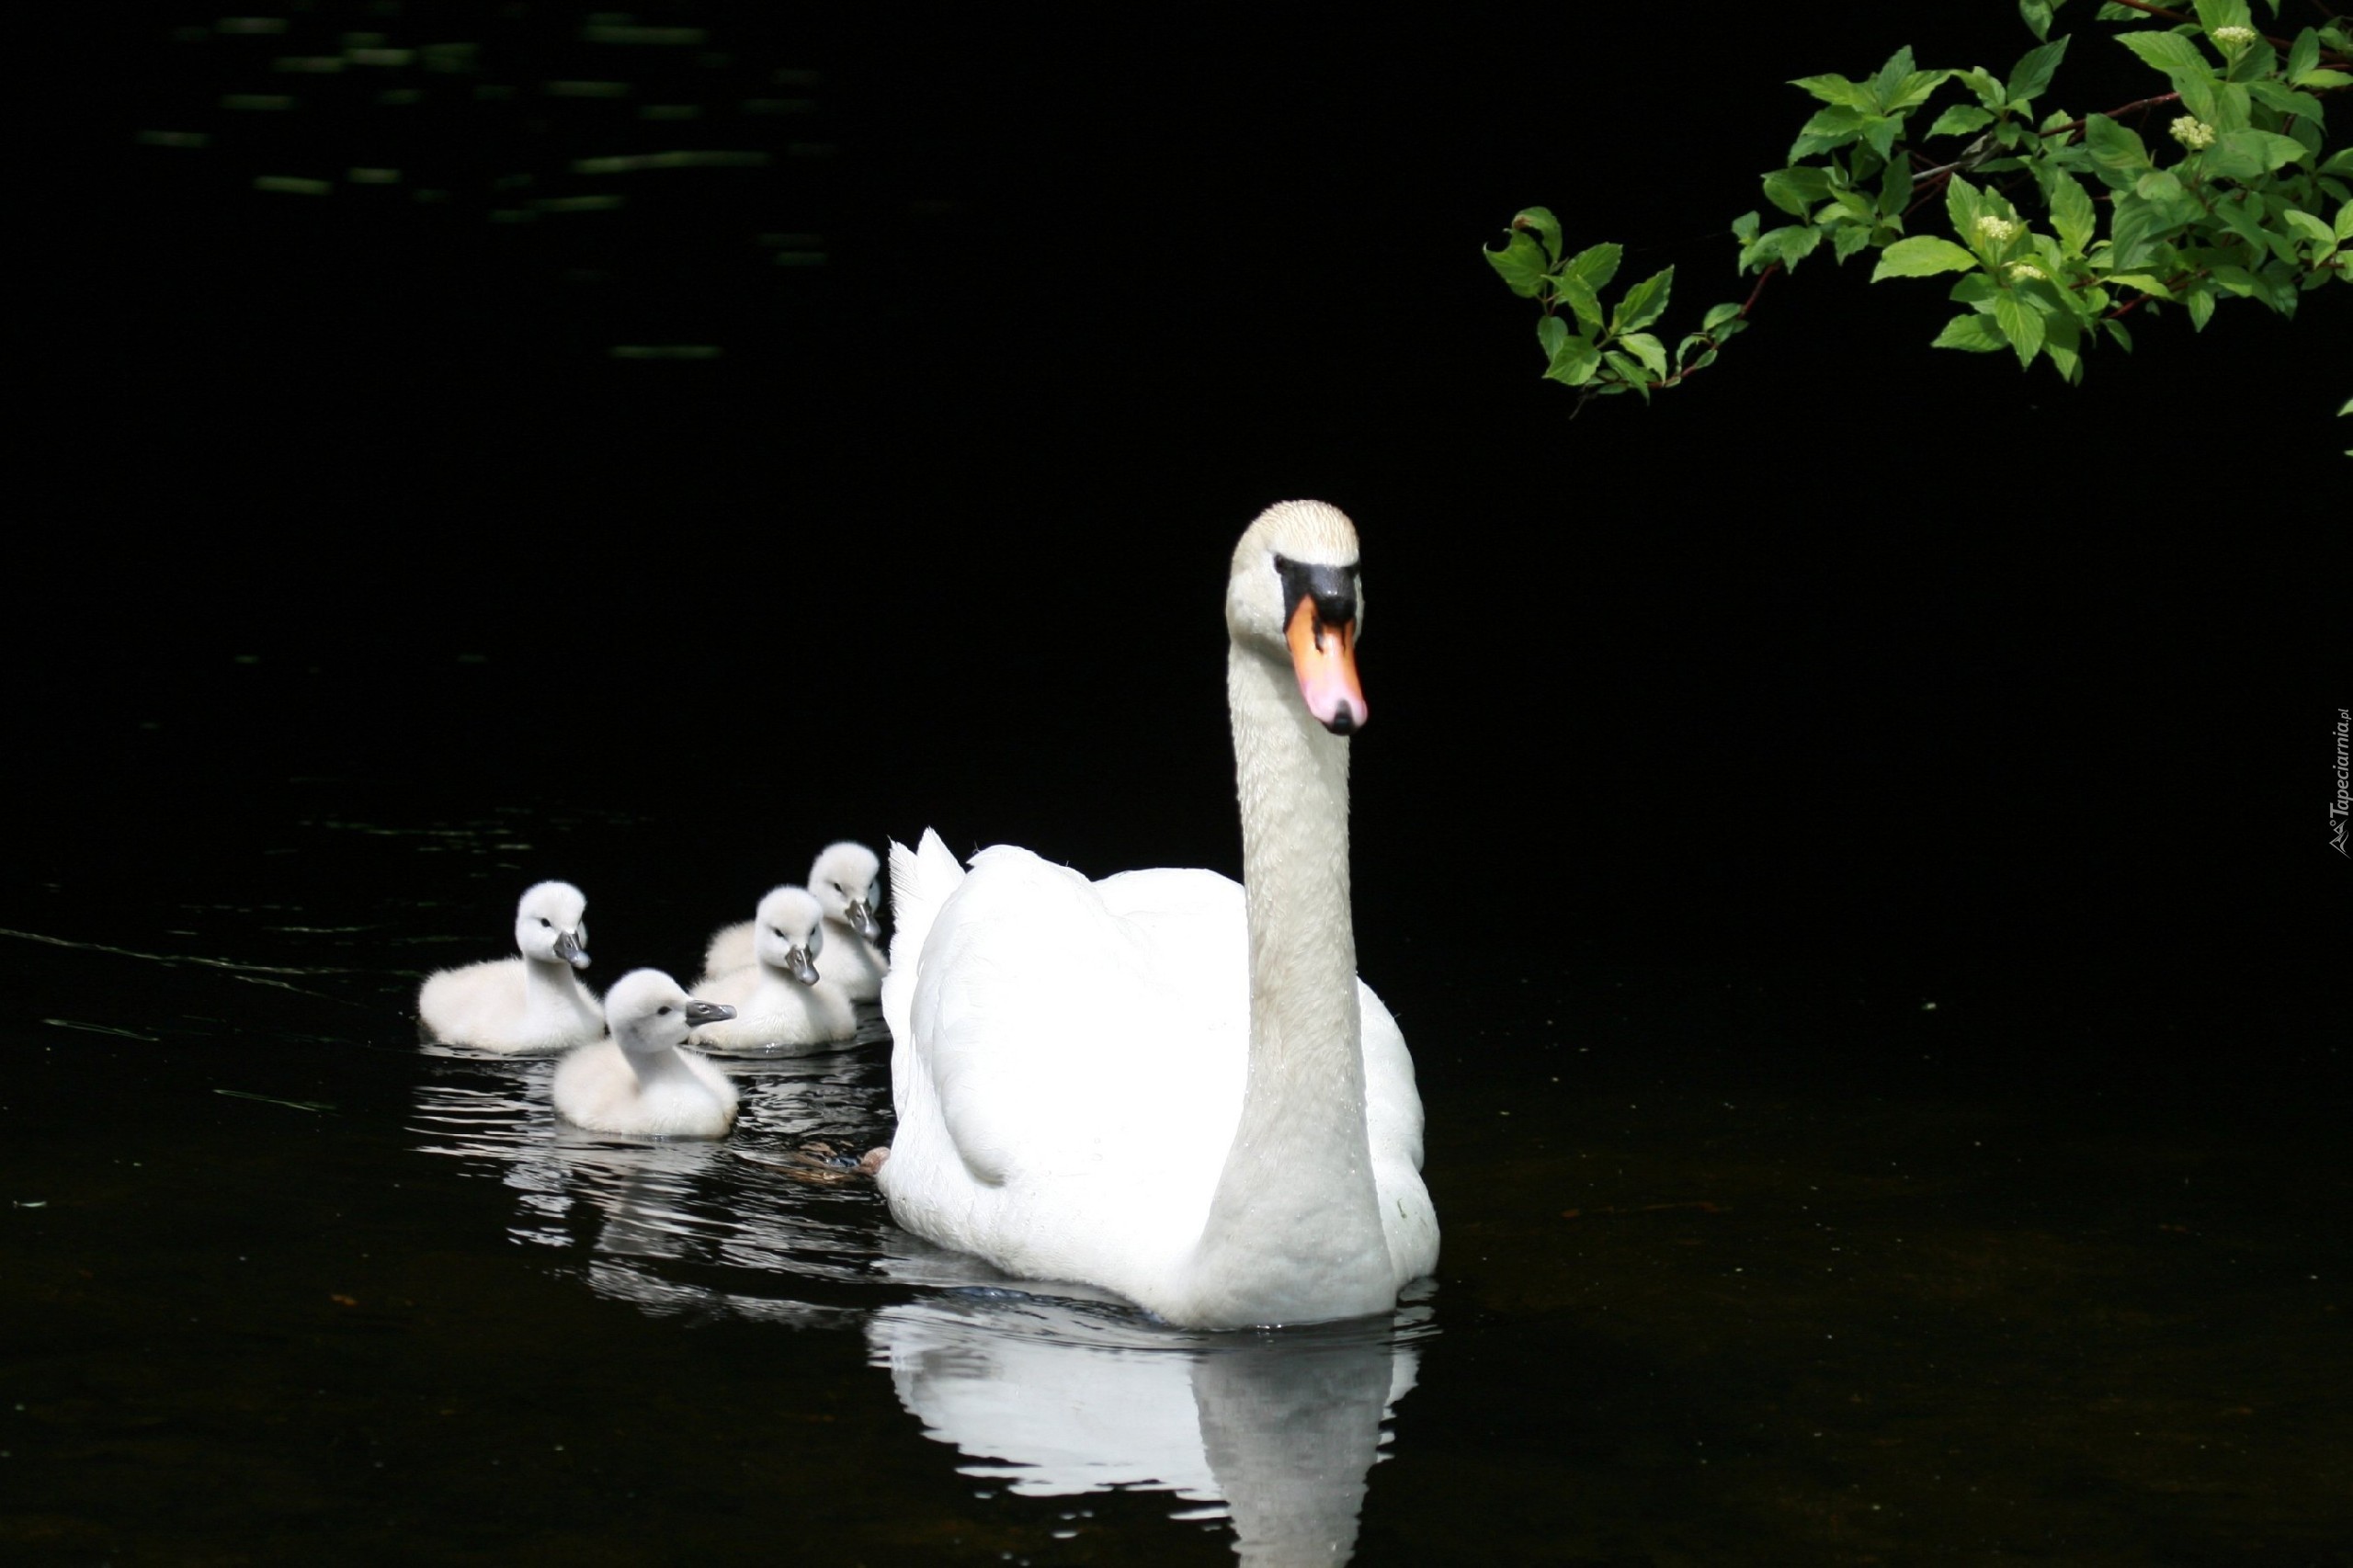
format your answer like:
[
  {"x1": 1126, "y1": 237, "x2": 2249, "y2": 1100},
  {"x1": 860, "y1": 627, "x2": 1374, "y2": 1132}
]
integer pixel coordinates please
[{"x1": 555, "y1": 970, "x2": 736, "y2": 1137}]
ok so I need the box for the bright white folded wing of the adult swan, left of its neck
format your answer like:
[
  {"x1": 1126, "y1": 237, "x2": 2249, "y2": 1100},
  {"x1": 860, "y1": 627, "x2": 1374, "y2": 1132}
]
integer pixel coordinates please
[{"x1": 885, "y1": 847, "x2": 1249, "y2": 1288}]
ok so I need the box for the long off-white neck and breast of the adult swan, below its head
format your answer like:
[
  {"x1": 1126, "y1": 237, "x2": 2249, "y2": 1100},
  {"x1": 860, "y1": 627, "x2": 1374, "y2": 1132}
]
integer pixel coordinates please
[{"x1": 1195, "y1": 645, "x2": 1395, "y2": 1324}]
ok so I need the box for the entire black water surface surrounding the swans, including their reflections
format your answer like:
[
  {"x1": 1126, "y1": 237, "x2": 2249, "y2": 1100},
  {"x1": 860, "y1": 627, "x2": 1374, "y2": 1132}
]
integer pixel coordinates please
[{"x1": 22, "y1": 0, "x2": 2353, "y2": 1568}]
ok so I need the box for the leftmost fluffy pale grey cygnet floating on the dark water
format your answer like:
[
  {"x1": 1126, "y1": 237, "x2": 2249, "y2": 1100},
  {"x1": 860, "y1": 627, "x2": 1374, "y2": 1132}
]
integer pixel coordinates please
[{"x1": 416, "y1": 883, "x2": 605, "y2": 1050}]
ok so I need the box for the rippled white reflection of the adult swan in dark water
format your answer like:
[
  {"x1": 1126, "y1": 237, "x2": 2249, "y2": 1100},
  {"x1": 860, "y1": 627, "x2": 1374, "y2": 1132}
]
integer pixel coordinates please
[{"x1": 866, "y1": 1292, "x2": 1426, "y2": 1563}]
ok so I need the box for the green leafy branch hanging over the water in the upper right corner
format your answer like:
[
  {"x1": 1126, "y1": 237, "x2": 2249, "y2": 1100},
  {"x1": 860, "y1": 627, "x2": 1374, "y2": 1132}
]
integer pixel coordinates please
[{"x1": 1484, "y1": 0, "x2": 2353, "y2": 403}]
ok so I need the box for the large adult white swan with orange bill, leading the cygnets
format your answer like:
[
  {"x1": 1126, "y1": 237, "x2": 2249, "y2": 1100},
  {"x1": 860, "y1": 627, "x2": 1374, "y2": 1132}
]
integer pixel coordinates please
[{"x1": 870, "y1": 502, "x2": 1438, "y2": 1328}]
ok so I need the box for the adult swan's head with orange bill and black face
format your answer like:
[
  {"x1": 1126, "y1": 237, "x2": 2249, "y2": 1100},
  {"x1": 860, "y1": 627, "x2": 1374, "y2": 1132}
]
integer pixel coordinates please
[{"x1": 1226, "y1": 502, "x2": 1370, "y2": 734}]
